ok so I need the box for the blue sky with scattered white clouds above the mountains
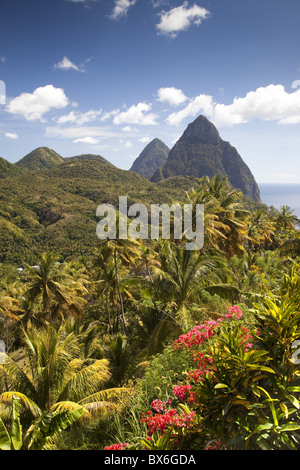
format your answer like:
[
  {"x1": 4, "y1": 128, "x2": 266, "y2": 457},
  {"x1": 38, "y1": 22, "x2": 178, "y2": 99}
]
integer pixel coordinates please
[{"x1": 0, "y1": 0, "x2": 300, "y2": 183}]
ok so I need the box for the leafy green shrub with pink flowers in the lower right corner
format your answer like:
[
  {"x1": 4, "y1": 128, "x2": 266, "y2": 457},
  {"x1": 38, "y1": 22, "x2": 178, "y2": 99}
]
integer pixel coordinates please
[{"x1": 106, "y1": 288, "x2": 300, "y2": 450}]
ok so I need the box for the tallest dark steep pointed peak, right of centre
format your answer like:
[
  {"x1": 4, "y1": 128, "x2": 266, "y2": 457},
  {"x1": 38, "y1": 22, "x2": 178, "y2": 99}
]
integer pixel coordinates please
[{"x1": 151, "y1": 115, "x2": 261, "y2": 202}]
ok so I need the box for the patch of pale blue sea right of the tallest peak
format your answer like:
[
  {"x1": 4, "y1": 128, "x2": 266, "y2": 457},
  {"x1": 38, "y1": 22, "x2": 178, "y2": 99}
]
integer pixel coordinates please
[{"x1": 258, "y1": 183, "x2": 300, "y2": 218}]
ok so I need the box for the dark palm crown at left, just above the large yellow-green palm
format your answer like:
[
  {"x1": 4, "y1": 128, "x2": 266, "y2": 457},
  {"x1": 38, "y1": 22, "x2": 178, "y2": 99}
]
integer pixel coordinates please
[{"x1": 26, "y1": 252, "x2": 88, "y2": 325}]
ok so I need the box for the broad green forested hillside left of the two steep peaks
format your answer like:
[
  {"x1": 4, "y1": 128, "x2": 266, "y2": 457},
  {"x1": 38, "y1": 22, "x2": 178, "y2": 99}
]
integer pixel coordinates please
[{"x1": 0, "y1": 156, "x2": 199, "y2": 265}]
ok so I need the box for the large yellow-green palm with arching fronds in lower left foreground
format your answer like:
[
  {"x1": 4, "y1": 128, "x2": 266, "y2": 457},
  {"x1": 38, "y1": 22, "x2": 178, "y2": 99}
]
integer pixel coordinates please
[{"x1": 0, "y1": 326, "x2": 126, "y2": 418}]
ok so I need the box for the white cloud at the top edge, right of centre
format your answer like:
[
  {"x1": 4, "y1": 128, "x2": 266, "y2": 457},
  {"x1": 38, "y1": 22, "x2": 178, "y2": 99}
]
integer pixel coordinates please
[{"x1": 156, "y1": 2, "x2": 210, "y2": 38}]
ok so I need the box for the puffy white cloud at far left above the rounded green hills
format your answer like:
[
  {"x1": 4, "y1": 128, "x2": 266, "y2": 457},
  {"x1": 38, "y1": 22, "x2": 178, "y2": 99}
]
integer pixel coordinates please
[{"x1": 6, "y1": 85, "x2": 69, "y2": 121}]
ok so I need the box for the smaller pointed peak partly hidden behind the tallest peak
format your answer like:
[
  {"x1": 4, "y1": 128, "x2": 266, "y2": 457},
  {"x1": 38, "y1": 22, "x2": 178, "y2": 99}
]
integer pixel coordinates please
[{"x1": 130, "y1": 138, "x2": 170, "y2": 179}]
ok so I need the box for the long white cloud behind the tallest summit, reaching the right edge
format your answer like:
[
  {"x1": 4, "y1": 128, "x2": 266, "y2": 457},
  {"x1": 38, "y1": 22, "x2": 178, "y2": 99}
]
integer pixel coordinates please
[{"x1": 167, "y1": 85, "x2": 300, "y2": 127}]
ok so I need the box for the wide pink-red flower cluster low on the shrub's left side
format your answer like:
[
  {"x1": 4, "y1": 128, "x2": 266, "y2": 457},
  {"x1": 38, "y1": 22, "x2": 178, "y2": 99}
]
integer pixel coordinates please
[{"x1": 141, "y1": 408, "x2": 195, "y2": 436}]
